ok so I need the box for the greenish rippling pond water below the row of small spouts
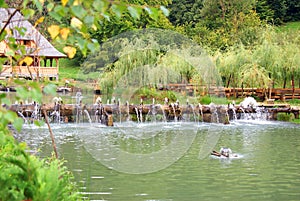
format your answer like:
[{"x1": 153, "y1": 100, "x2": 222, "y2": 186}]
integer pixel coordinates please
[{"x1": 17, "y1": 121, "x2": 300, "y2": 200}]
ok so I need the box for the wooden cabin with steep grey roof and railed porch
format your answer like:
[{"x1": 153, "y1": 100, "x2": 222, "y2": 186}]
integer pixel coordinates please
[{"x1": 0, "y1": 8, "x2": 66, "y2": 80}]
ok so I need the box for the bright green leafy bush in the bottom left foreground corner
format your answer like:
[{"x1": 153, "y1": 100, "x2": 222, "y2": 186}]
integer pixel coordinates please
[{"x1": 0, "y1": 130, "x2": 80, "y2": 201}]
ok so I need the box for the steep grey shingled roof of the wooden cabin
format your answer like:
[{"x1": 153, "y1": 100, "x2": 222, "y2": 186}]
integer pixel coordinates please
[{"x1": 0, "y1": 8, "x2": 66, "y2": 58}]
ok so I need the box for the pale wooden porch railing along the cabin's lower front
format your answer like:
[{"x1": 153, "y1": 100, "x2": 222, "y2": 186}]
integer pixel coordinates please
[{"x1": 0, "y1": 65, "x2": 58, "y2": 78}]
